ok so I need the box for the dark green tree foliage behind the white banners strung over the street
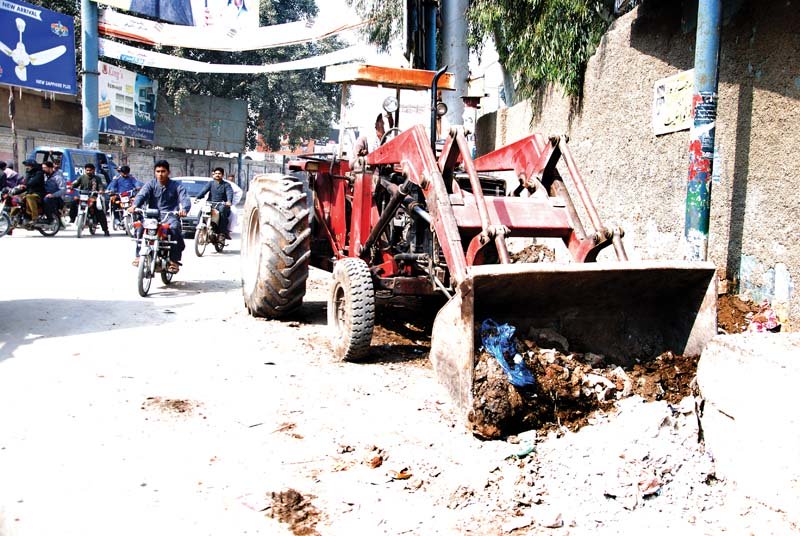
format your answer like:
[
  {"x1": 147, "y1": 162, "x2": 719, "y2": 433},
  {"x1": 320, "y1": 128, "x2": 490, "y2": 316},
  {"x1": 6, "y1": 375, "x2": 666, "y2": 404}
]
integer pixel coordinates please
[{"x1": 35, "y1": 0, "x2": 344, "y2": 149}]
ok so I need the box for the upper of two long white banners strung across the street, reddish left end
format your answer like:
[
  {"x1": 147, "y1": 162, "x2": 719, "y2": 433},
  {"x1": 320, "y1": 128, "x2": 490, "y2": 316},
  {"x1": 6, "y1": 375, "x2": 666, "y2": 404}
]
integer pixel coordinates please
[{"x1": 98, "y1": 9, "x2": 365, "y2": 52}]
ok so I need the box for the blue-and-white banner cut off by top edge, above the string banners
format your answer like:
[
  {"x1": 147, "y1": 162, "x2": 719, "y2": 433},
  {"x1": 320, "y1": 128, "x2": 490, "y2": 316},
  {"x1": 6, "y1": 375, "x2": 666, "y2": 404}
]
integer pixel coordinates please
[{"x1": 94, "y1": 0, "x2": 259, "y2": 28}]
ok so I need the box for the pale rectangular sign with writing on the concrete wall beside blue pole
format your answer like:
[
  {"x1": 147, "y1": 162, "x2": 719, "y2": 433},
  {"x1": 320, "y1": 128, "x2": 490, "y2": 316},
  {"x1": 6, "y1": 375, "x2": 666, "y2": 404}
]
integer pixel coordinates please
[{"x1": 653, "y1": 69, "x2": 694, "y2": 136}]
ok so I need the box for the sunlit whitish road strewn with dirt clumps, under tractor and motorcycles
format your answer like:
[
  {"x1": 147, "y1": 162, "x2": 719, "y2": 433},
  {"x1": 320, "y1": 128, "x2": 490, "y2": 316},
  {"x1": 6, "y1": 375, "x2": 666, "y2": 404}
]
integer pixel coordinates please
[{"x1": 0, "y1": 229, "x2": 792, "y2": 536}]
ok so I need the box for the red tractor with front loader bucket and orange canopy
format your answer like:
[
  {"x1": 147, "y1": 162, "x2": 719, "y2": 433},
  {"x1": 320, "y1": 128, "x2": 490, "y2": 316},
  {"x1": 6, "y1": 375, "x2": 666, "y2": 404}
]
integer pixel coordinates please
[{"x1": 236, "y1": 66, "x2": 716, "y2": 422}]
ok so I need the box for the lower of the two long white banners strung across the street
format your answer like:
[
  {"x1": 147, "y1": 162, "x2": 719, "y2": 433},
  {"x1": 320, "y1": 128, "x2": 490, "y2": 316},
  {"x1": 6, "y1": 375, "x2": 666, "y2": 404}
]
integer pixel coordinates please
[{"x1": 99, "y1": 38, "x2": 363, "y2": 74}]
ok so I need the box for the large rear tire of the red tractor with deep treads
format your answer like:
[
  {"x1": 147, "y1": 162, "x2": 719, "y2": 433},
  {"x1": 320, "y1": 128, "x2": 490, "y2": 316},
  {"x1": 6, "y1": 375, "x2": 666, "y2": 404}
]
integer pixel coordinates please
[{"x1": 241, "y1": 173, "x2": 311, "y2": 318}]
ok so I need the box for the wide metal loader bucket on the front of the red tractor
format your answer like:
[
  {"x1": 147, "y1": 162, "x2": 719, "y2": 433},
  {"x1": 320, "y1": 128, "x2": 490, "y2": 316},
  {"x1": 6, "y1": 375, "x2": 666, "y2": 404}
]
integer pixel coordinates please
[{"x1": 430, "y1": 261, "x2": 717, "y2": 424}]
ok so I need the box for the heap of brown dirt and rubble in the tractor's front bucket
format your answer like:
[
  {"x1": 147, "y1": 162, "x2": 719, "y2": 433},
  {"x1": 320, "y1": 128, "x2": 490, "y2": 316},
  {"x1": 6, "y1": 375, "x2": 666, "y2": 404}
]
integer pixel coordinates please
[{"x1": 469, "y1": 322, "x2": 698, "y2": 439}]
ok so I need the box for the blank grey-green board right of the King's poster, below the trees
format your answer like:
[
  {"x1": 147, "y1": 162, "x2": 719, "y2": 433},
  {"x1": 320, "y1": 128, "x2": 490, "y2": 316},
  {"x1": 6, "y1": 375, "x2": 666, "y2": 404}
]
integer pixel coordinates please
[{"x1": 155, "y1": 95, "x2": 247, "y2": 153}]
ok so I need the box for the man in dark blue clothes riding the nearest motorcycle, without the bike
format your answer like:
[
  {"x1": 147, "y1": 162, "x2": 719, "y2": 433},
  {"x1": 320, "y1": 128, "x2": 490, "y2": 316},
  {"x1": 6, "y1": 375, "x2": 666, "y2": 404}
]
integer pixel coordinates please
[{"x1": 128, "y1": 160, "x2": 192, "y2": 274}]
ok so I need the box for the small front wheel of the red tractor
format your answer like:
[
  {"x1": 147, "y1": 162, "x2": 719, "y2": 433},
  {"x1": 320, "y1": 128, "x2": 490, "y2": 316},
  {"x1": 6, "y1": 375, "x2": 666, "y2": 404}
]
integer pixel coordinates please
[{"x1": 328, "y1": 257, "x2": 375, "y2": 361}]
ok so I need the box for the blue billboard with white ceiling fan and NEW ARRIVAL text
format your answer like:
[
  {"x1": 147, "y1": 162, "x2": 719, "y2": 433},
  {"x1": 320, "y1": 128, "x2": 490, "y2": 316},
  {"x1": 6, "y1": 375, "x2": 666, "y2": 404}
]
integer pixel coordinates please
[{"x1": 0, "y1": 0, "x2": 78, "y2": 95}]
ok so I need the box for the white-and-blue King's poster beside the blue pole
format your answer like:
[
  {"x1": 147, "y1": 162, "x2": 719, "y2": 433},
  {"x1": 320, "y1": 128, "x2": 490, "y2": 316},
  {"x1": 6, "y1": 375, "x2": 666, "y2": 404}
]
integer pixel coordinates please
[{"x1": 97, "y1": 61, "x2": 158, "y2": 141}]
